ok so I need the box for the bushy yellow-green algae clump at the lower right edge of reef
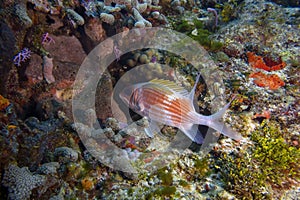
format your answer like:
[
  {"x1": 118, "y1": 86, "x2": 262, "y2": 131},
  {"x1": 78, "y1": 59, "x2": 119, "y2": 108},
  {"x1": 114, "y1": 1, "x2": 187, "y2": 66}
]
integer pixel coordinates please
[{"x1": 251, "y1": 121, "x2": 300, "y2": 186}]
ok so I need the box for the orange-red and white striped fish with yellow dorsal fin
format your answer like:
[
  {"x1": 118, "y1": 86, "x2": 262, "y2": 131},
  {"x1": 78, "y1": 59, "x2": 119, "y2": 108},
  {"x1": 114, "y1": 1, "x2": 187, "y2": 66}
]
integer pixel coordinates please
[{"x1": 120, "y1": 74, "x2": 242, "y2": 144}]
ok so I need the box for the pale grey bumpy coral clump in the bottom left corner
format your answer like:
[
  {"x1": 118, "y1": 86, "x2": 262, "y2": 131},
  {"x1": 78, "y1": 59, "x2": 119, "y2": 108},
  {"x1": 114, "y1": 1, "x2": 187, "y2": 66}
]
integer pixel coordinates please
[{"x1": 2, "y1": 165, "x2": 46, "y2": 200}]
